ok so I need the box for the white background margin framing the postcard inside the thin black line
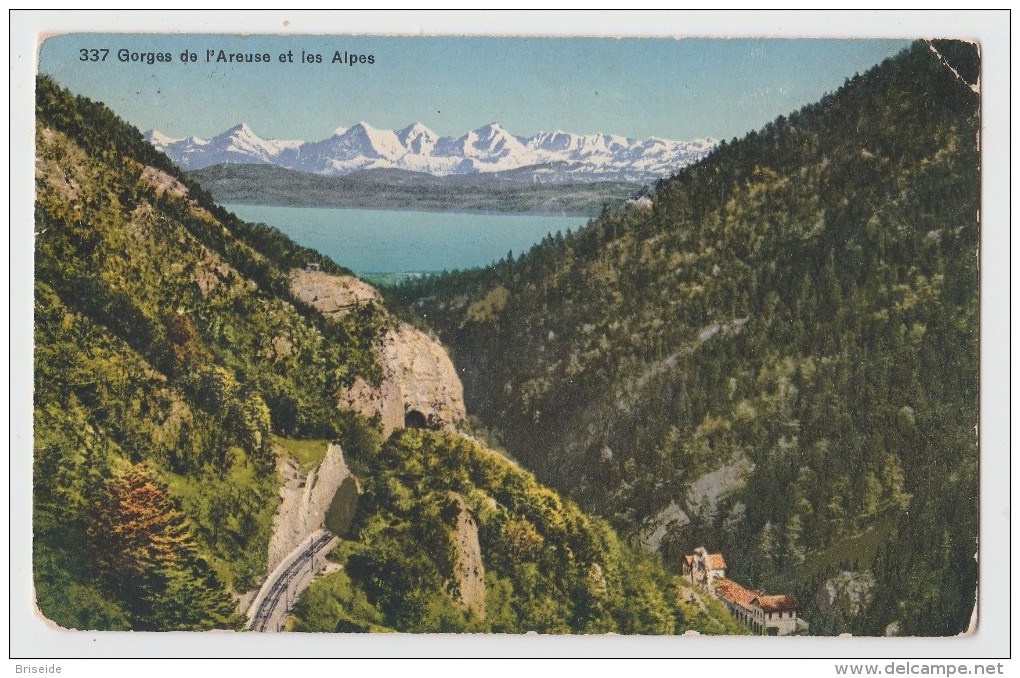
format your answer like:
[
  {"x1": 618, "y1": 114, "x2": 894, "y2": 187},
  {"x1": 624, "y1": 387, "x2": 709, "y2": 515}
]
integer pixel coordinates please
[{"x1": 8, "y1": 10, "x2": 1012, "y2": 664}]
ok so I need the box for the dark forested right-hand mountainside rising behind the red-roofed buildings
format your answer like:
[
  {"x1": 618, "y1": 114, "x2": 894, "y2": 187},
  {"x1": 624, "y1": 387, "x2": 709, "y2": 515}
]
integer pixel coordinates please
[{"x1": 398, "y1": 41, "x2": 979, "y2": 635}]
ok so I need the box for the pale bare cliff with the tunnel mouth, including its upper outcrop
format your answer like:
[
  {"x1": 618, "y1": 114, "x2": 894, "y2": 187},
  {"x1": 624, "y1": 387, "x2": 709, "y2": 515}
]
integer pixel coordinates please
[{"x1": 291, "y1": 270, "x2": 466, "y2": 434}]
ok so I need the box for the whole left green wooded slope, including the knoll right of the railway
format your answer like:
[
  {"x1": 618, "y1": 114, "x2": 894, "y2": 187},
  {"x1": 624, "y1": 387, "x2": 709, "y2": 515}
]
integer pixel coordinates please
[{"x1": 24, "y1": 76, "x2": 740, "y2": 633}]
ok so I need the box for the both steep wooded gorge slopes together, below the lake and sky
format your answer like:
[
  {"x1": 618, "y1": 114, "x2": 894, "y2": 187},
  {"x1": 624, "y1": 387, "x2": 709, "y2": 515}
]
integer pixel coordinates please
[{"x1": 33, "y1": 41, "x2": 980, "y2": 635}]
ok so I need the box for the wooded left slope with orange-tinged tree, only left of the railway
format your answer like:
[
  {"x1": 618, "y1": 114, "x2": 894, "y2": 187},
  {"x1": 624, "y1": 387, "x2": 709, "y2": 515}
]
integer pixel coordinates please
[{"x1": 34, "y1": 77, "x2": 391, "y2": 629}]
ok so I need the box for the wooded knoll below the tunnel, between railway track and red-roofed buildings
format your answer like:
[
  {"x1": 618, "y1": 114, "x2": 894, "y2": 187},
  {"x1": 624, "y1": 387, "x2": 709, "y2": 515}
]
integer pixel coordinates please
[{"x1": 293, "y1": 429, "x2": 745, "y2": 634}]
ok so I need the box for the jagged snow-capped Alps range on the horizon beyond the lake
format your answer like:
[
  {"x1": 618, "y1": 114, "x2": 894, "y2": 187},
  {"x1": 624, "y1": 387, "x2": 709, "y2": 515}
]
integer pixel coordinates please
[{"x1": 146, "y1": 122, "x2": 716, "y2": 181}]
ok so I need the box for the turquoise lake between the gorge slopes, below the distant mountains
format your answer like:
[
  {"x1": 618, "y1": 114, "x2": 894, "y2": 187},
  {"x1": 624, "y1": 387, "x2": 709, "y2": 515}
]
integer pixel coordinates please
[{"x1": 223, "y1": 204, "x2": 588, "y2": 281}]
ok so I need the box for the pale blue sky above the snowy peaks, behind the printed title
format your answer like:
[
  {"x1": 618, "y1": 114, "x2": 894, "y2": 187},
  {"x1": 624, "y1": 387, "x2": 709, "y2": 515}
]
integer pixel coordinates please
[{"x1": 39, "y1": 34, "x2": 909, "y2": 140}]
